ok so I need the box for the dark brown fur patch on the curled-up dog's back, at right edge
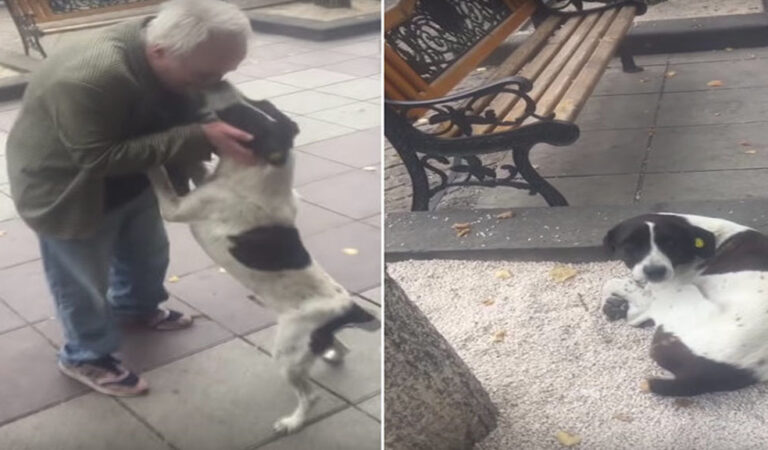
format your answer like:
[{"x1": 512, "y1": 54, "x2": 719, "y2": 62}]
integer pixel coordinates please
[{"x1": 702, "y1": 230, "x2": 768, "y2": 275}]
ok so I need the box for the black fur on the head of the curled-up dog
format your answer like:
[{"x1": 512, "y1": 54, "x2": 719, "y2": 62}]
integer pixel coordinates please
[{"x1": 603, "y1": 214, "x2": 716, "y2": 268}]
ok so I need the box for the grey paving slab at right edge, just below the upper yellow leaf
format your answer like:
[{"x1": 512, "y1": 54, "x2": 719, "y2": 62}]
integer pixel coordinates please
[{"x1": 658, "y1": 87, "x2": 768, "y2": 127}]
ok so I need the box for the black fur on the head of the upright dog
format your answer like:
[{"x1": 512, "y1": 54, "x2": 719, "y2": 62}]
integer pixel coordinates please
[{"x1": 216, "y1": 100, "x2": 299, "y2": 166}]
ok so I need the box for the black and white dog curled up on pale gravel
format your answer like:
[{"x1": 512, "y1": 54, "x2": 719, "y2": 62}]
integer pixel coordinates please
[{"x1": 603, "y1": 213, "x2": 768, "y2": 396}]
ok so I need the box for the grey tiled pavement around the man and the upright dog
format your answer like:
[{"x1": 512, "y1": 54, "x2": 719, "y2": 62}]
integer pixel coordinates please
[{"x1": 0, "y1": 23, "x2": 381, "y2": 450}]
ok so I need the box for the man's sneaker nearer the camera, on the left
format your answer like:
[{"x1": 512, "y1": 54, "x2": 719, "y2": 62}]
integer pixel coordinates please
[{"x1": 59, "y1": 355, "x2": 149, "y2": 397}]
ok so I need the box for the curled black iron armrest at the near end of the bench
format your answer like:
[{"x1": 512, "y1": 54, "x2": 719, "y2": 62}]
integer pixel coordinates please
[{"x1": 384, "y1": 76, "x2": 552, "y2": 136}]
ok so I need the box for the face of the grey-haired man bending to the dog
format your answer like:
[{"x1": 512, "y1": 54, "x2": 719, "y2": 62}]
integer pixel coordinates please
[{"x1": 147, "y1": 36, "x2": 247, "y2": 92}]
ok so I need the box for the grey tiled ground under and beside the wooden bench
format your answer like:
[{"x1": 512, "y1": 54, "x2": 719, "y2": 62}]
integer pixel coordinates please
[{"x1": 385, "y1": 48, "x2": 768, "y2": 210}]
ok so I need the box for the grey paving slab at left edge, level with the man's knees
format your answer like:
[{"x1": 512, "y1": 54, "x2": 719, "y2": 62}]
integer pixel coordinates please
[{"x1": 0, "y1": 260, "x2": 56, "y2": 323}]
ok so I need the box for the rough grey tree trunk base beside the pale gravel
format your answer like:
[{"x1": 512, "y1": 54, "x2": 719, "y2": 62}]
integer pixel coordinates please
[{"x1": 384, "y1": 274, "x2": 498, "y2": 450}]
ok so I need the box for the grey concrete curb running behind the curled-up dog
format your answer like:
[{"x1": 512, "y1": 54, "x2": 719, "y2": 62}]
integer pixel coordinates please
[{"x1": 384, "y1": 199, "x2": 768, "y2": 262}]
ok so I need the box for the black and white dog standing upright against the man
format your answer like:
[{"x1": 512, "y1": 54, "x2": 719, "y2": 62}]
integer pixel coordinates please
[{"x1": 148, "y1": 85, "x2": 380, "y2": 432}]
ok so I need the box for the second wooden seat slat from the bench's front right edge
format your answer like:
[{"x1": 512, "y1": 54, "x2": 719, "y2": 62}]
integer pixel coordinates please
[{"x1": 536, "y1": 9, "x2": 618, "y2": 116}]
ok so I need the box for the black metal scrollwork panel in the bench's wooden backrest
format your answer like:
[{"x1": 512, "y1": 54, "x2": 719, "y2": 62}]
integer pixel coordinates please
[{"x1": 385, "y1": 0, "x2": 512, "y2": 82}]
